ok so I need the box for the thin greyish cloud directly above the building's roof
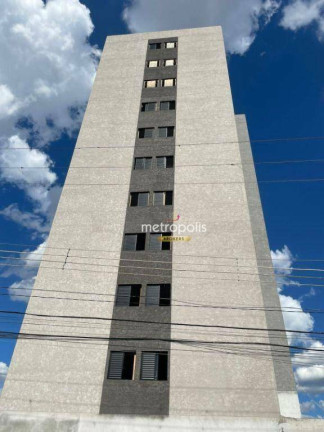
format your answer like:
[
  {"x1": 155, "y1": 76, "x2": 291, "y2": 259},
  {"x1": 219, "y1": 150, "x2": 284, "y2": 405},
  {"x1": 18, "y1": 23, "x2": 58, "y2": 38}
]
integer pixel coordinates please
[{"x1": 123, "y1": 0, "x2": 280, "y2": 54}]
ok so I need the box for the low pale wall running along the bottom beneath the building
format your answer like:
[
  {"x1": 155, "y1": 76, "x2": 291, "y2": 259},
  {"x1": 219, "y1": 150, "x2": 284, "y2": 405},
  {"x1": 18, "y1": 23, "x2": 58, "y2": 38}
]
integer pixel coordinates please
[{"x1": 0, "y1": 412, "x2": 324, "y2": 432}]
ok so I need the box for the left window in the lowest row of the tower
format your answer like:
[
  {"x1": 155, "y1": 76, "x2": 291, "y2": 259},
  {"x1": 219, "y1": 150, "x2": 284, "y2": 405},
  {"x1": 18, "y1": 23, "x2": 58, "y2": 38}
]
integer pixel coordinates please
[{"x1": 108, "y1": 351, "x2": 136, "y2": 380}]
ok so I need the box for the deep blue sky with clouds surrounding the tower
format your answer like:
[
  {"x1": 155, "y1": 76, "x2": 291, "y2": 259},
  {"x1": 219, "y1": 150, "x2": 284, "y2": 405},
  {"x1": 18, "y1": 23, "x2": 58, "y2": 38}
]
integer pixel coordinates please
[{"x1": 0, "y1": 0, "x2": 324, "y2": 416}]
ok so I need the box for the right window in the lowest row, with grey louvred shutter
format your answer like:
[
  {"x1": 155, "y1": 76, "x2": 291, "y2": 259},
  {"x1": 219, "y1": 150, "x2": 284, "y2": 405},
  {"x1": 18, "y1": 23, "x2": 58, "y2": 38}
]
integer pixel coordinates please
[{"x1": 141, "y1": 351, "x2": 168, "y2": 381}]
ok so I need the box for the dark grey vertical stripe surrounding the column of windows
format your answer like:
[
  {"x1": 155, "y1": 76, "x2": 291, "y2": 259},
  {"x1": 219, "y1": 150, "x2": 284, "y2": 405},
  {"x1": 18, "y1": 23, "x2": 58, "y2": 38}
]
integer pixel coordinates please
[{"x1": 100, "y1": 38, "x2": 178, "y2": 415}]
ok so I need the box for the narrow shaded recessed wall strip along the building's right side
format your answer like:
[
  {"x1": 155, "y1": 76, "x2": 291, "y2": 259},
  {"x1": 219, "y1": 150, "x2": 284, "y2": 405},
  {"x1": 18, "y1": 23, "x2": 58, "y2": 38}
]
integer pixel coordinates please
[{"x1": 236, "y1": 115, "x2": 296, "y2": 392}]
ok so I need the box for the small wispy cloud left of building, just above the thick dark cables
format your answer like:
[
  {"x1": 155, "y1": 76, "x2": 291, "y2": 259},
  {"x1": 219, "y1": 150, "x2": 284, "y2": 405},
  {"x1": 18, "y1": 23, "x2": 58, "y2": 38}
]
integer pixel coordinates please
[{"x1": 1, "y1": 241, "x2": 46, "y2": 302}]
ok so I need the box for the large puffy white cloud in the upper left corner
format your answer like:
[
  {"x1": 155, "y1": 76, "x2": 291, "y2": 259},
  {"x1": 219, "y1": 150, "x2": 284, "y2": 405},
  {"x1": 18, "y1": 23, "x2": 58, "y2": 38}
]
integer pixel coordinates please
[{"x1": 0, "y1": 0, "x2": 99, "y2": 143}]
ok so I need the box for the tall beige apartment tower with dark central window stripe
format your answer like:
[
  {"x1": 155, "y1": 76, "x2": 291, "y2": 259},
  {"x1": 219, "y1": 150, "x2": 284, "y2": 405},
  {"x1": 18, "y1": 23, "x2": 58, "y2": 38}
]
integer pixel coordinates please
[{"x1": 0, "y1": 27, "x2": 299, "y2": 417}]
